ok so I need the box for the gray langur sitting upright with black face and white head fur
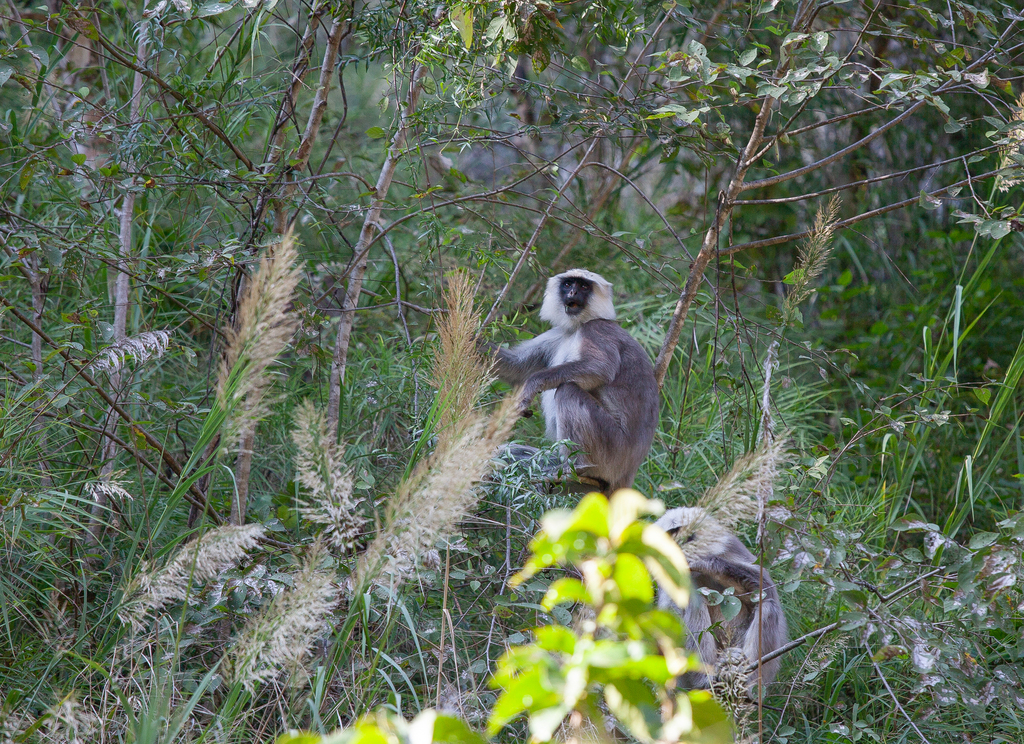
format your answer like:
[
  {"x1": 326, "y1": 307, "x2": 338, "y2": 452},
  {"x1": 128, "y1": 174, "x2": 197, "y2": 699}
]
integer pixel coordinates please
[{"x1": 483, "y1": 269, "x2": 658, "y2": 493}]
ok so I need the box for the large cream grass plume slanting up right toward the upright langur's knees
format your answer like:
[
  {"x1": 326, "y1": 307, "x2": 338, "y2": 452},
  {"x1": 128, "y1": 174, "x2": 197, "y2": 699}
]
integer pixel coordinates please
[{"x1": 356, "y1": 395, "x2": 518, "y2": 587}]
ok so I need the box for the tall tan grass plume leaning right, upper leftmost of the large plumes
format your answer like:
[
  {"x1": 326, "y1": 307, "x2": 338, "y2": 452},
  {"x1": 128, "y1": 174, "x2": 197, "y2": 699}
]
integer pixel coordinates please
[{"x1": 217, "y1": 232, "x2": 302, "y2": 430}]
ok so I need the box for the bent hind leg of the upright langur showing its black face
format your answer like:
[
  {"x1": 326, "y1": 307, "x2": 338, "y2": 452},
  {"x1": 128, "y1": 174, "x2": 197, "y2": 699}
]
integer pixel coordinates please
[{"x1": 555, "y1": 383, "x2": 628, "y2": 489}]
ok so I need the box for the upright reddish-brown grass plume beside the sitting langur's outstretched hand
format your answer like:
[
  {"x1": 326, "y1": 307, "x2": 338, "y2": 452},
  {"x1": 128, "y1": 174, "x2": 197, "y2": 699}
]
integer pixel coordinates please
[{"x1": 431, "y1": 271, "x2": 489, "y2": 449}]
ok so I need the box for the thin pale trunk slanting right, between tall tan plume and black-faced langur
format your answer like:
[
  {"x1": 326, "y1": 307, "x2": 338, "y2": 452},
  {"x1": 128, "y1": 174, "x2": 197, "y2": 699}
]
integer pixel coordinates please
[{"x1": 327, "y1": 58, "x2": 427, "y2": 441}]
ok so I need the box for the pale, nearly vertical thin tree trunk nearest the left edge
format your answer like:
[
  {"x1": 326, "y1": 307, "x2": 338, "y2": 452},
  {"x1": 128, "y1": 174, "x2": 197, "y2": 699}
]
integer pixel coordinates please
[{"x1": 87, "y1": 19, "x2": 148, "y2": 545}]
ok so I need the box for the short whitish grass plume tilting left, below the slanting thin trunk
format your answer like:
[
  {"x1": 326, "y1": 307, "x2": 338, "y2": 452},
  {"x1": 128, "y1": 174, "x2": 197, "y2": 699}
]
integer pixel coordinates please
[{"x1": 292, "y1": 399, "x2": 367, "y2": 554}]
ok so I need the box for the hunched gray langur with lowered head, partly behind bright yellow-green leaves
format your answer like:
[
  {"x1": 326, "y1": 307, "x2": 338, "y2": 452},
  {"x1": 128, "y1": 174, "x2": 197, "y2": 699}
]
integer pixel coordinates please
[{"x1": 655, "y1": 507, "x2": 787, "y2": 699}]
